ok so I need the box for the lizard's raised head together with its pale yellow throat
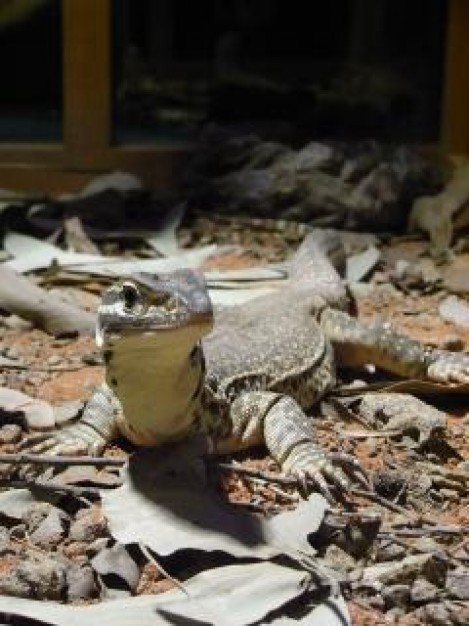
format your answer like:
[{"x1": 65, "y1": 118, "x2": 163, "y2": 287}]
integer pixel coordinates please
[{"x1": 96, "y1": 270, "x2": 213, "y2": 445}]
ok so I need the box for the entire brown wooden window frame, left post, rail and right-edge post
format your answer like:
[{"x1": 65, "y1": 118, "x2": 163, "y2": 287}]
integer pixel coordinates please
[{"x1": 0, "y1": 0, "x2": 469, "y2": 193}]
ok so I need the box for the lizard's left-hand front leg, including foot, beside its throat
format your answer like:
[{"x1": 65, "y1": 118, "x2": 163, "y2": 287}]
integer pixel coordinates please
[{"x1": 21, "y1": 384, "x2": 122, "y2": 455}]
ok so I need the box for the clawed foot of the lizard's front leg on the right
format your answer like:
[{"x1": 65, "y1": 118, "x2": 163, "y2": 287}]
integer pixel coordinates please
[{"x1": 282, "y1": 442, "x2": 369, "y2": 502}]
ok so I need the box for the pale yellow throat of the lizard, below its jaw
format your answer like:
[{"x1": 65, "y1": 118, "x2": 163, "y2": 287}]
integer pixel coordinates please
[{"x1": 106, "y1": 328, "x2": 203, "y2": 446}]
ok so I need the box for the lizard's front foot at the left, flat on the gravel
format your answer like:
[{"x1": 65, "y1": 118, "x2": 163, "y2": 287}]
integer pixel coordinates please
[{"x1": 15, "y1": 422, "x2": 106, "y2": 479}]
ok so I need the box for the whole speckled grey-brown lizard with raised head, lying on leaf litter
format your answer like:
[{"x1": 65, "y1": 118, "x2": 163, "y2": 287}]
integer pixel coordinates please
[{"x1": 21, "y1": 229, "x2": 469, "y2": 493}]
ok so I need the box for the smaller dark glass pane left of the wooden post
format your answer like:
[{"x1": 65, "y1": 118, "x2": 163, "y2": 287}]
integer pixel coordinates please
[{"x1": 0, "y1": 0, "x2": 62, "y2": 142}]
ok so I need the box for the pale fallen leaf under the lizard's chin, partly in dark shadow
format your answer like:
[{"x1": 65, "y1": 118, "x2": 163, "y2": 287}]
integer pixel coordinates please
[{"x1": 102, "y1": 441, "x2": 327, "y2": 558}]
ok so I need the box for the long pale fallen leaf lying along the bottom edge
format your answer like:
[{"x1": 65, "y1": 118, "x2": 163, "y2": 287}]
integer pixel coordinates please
[{"x1": 0, "y1": 562, "x2": 351, "y2": 626}]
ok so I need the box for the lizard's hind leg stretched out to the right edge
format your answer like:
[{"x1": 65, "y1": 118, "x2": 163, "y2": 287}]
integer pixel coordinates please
[{"x1": 320, "y1": 309, "x2": 469, "y2": 383}]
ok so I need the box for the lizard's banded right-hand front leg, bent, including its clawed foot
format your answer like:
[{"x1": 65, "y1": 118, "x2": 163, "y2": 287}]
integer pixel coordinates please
[{"x1": 214, "y1": 391, "x2": 359, "y2": 495}]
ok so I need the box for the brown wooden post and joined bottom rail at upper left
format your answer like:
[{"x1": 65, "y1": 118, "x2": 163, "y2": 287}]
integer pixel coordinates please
[{"x1": 0, "y1": 0, "x2": 188, "y2": 193}]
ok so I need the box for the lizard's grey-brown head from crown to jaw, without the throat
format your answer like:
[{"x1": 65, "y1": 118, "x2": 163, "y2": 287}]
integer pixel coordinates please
[{"x1": 96, "y1": 270, "x2": 213, "y2": 348}]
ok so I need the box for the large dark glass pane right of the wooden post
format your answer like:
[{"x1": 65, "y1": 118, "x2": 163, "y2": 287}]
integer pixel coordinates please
[{"x1": 113, "y1": 0, "x2": 447, "y2": 142}]
